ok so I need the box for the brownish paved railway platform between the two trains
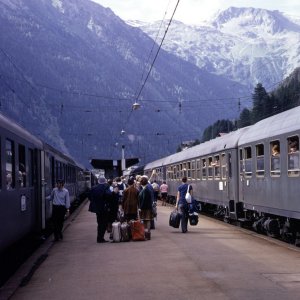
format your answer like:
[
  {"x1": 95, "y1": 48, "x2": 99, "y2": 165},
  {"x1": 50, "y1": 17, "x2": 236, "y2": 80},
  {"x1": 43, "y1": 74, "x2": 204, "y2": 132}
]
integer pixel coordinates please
[{"x1": 0, "y1": 203, "x2": 300, "y2": 300}]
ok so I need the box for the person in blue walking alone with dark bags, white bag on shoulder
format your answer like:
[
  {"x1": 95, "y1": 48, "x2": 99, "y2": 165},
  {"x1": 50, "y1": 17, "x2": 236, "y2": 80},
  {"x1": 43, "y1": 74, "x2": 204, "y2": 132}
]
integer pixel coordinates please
[{"x1": 176, "y1": 177, "x2": 193, "y2": 233}]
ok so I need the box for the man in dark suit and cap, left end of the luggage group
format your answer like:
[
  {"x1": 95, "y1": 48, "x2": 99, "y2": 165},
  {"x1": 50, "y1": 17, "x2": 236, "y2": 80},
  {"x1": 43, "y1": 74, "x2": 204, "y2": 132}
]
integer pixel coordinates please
[{"x1": 89, "y1": 177, "x2": 112, "y2": 243}]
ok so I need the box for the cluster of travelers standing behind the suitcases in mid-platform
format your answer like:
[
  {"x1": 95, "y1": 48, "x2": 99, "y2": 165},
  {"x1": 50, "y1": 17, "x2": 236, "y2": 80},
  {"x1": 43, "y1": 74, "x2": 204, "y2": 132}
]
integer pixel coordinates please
[{"x1": 89, "y1": 176, "x2": 157, "y2": 243}]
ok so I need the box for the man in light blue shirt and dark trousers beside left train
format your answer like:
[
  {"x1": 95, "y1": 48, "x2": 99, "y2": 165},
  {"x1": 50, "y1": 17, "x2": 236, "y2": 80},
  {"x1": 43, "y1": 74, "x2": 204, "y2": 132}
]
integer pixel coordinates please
[{"x1": 50, "y1": 179, "x2": 70, "y2": 241}]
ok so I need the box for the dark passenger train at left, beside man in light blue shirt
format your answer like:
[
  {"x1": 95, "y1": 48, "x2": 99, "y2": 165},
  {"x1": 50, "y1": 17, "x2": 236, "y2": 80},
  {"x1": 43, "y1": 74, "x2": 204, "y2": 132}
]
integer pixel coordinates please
[{"x1": 0, "y1": 114, "x2": 91, "y2": 253}]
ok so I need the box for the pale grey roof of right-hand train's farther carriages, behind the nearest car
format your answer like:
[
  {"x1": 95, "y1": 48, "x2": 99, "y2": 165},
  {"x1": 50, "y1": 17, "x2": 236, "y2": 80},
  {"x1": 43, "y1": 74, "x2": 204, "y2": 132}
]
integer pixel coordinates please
[{"x1": 145, "y1": 127, "x2": 249, "y2": 170}]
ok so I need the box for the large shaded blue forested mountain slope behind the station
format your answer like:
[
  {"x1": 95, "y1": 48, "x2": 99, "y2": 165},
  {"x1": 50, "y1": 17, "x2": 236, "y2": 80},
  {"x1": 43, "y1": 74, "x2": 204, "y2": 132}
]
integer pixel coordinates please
[{"x1": 0, "y1": 0, "x2": 247, "y2": 165}]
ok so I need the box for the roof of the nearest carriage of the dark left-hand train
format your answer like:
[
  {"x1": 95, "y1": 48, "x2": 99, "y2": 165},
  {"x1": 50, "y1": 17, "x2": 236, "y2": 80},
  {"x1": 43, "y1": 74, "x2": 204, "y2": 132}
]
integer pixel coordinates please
[{"x1": 0, "y1": 114, "x2": 43, "y2": 148}]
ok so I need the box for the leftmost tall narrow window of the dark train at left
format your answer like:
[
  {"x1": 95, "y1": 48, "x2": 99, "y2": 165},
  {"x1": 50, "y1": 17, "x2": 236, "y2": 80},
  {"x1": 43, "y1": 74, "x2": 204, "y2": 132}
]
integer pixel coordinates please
[{"x1": 5, "y1": 139, "x2": 15, "y2": 190}]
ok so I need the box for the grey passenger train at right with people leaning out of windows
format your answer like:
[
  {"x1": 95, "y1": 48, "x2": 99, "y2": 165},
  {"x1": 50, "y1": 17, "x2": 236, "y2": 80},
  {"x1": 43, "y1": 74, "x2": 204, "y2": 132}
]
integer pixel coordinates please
[{"x1": 144, "y1": 107, "x2": 300, "y2": 244}]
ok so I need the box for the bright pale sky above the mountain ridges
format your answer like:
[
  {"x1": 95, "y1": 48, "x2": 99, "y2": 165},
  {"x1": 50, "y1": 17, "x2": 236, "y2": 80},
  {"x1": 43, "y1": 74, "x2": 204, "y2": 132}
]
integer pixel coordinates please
[{"x1": 92, "y1": 0, "x2": 300, "y2": 24}]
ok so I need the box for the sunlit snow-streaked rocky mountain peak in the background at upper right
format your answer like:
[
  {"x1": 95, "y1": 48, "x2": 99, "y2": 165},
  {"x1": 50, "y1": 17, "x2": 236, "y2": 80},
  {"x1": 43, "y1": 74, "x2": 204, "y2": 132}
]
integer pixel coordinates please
[{"x1": 134, "y1": 7, "x2": 300, "y2": 89}]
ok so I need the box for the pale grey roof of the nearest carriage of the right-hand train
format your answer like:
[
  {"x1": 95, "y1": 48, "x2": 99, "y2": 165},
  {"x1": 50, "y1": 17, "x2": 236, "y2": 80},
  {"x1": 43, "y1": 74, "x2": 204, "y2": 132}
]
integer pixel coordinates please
[{"x1": 239, "y1": 106, "x2": 300, "y2": 145}]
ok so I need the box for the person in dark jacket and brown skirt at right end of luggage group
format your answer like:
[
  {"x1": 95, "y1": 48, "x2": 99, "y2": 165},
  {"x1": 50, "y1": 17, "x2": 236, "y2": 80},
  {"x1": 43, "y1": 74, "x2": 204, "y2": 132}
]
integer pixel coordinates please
[{"x1": 138, "y1": 177, "x2": 153, "y2": 240}]
